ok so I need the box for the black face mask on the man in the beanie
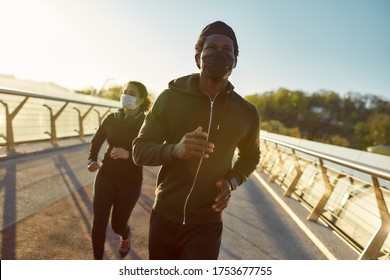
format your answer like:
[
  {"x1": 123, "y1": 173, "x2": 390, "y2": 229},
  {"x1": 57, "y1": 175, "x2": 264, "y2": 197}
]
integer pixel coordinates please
[{"x1": 202, "y1": 51, "x2": 234, "y2": 83}]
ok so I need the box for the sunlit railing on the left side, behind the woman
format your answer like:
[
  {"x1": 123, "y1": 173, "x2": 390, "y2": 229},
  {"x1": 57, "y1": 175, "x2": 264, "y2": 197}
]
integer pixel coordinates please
[{"x1": 0, "y1": 88, "x2": 119, "y2": 152}]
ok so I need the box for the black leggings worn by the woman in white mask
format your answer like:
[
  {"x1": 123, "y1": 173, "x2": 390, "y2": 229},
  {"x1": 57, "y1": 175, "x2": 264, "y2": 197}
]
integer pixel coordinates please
[{"x1": 92, "y1": 170, "x2": 142, "y2": 260}]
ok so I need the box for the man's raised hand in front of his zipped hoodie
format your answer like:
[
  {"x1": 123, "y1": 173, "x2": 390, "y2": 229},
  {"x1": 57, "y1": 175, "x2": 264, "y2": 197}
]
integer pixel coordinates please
[{"x1": 171, "y1": 127, "x2": 214, "y2": 160}]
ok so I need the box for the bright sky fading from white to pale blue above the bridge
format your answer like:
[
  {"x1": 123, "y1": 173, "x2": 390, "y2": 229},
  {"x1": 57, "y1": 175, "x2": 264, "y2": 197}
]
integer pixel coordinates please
[{"x1": 0, "y1": 0, "x2": 390, "y2": 100}]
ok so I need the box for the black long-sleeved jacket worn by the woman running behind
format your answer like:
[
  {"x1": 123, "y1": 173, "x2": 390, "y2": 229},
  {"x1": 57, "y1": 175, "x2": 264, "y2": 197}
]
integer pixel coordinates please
[{"x1": 88, "y1": 109, "x2": 145, "y2": 180}]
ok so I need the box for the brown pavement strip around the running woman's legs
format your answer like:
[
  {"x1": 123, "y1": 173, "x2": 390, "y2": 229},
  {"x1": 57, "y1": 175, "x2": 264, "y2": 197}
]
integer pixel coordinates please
[{"x1": 0, "y1": 164, "x2": 158, "y2": 260}]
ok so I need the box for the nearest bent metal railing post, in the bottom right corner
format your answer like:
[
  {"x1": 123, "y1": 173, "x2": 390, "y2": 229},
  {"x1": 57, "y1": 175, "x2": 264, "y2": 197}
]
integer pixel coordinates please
[{"x1": 359, "y1": 176, "x2": 390, "y2": 260}]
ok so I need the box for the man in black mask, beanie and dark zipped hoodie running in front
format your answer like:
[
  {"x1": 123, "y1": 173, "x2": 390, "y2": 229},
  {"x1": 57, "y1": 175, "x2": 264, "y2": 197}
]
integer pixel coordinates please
[{"x1": 133, "y1": 21, "x2": 260, "y2": 260}]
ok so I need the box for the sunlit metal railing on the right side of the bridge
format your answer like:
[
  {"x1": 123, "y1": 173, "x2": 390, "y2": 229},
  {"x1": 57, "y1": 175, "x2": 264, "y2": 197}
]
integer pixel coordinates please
[{"x1": 259, "y1": 133, "x2": 390, "y2": 259}]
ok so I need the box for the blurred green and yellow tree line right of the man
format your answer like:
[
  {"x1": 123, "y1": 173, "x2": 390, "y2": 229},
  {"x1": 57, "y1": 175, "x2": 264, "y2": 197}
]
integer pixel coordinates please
[{"x1": 245, "y1": 88, "x2": 390, "y2": 155}]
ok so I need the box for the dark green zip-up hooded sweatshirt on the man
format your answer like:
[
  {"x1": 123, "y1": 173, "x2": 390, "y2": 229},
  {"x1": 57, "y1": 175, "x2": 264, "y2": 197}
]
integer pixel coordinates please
[{"x1": 133, "y1": 74, "x2": 260, "y2": 224}]
